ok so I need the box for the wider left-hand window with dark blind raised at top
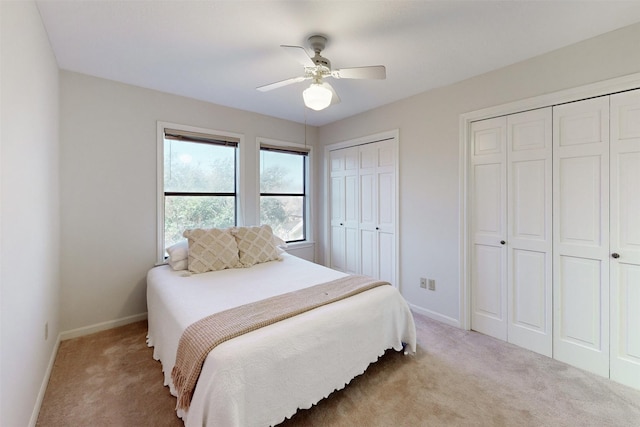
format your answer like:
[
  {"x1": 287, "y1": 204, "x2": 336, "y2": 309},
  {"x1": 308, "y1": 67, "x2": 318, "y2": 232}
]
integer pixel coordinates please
[{"x1": 159, "y1": 123, "x2": 239, "y2": 259}]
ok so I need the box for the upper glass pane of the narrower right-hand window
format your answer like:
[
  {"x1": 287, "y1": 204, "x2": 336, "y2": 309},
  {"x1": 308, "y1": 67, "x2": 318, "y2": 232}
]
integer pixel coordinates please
[{"x1": 260, "y1": 150, "x2": 305, "y2": 194}]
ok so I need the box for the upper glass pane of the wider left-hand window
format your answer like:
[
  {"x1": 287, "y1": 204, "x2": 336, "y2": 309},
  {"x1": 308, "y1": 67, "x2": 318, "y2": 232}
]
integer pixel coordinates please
[{"x1": 164, "y1": 139, "x2": 236, "y2": 193}]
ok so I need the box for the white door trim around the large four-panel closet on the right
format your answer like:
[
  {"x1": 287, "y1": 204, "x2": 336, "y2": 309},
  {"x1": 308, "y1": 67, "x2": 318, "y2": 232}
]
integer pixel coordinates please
[{"x1": 458, "y1": 73, "x2": 640, "y2": 330}]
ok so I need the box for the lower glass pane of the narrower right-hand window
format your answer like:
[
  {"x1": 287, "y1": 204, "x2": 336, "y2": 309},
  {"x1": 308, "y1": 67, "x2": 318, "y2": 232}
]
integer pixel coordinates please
[{"x1": 260, "y1": 196, "x2": 304, "y2": 242}]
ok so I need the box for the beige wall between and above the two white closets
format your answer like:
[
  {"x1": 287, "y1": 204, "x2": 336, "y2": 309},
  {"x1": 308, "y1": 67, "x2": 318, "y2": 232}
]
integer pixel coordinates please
[{"x1": 317, "y1": 24, "x2": 640, "y2": 324}]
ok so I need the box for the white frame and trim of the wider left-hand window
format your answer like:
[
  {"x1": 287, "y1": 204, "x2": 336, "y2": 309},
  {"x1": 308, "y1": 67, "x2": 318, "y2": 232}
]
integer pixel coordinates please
[{"x1": 156, "y1": 121, "x2": 244, "y2": 264}]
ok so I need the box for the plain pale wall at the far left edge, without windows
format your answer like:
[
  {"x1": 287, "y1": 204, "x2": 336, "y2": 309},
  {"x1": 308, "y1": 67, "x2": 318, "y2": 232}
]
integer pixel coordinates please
[{"x1": 0, "y1": 1, "x2": 60, "y2": 426}]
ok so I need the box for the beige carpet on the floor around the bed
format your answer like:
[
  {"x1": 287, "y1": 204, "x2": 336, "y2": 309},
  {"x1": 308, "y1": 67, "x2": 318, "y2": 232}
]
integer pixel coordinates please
[{"x1": 37, "y1": 314, "x2": 640, "y2": 427}]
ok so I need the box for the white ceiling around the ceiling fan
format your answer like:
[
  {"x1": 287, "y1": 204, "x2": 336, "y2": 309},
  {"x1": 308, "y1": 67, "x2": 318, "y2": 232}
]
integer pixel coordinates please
[{"x1": 37, "y1": 0, "x2": 640, "y2": 125}]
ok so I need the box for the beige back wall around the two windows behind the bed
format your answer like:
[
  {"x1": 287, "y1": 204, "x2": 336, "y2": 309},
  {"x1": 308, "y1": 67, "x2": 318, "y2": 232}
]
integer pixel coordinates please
[{"x1": 60, "y1": 71, "x2": 317, "y2": 331}]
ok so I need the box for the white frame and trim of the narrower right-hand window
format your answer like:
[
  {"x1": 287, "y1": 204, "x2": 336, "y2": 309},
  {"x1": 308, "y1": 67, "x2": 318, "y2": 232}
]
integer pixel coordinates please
[{"x1": 256, "y1": 137, "x2": 313, "y2": 244}]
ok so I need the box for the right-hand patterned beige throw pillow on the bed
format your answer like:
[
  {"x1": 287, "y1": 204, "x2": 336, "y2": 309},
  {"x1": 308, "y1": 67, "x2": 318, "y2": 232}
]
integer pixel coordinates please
[{"x1": 233, "y1": 225, "x2": 281, "y2": 267}]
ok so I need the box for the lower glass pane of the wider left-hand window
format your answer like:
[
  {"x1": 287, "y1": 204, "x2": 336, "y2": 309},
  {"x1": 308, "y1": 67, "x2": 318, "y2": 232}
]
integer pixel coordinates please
[{"x1": 164, "y1": 196, "x2": 235, "y2": 248}]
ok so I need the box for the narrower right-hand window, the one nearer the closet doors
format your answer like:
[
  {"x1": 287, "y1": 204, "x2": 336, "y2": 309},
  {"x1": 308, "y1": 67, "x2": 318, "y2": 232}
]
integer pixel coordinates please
[{"x1": 260, "y1": 144, "x2": 309, "y2": 243}]
